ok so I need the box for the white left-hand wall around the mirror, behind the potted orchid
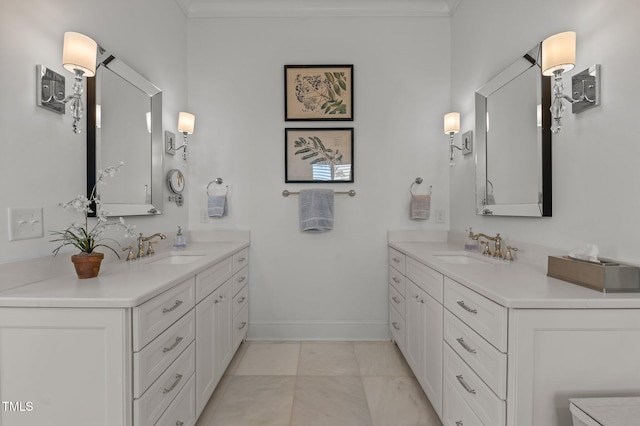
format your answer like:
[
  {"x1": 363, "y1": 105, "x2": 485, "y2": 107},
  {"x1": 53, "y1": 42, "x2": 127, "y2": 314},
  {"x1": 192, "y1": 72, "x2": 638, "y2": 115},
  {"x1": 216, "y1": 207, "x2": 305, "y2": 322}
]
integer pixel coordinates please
[{"x1": 0, "y1": 0, "x2": 187, "y2": 264}]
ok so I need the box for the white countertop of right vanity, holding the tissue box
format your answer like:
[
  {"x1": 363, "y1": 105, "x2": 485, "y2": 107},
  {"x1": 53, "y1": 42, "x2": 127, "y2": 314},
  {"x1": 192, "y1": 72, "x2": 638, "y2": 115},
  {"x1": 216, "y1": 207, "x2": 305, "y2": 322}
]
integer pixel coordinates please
[{"x1": 389, "y1": 241, "x2": 640, "y2": 309}]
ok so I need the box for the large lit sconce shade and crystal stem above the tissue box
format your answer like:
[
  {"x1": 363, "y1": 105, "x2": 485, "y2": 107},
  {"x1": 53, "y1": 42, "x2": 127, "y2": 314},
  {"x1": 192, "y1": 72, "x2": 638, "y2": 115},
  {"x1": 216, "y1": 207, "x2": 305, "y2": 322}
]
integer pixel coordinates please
[{"x1": 542, "y1": 31, "x2": 576, "y2": 133}]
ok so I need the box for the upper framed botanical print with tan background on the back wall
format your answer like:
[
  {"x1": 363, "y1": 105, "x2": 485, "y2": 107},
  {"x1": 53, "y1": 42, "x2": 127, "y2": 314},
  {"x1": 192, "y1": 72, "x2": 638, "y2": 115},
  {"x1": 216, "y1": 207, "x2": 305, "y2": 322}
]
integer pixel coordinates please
[{"x1": 285, "y1": 65, "x2": 353, "y2": 121}]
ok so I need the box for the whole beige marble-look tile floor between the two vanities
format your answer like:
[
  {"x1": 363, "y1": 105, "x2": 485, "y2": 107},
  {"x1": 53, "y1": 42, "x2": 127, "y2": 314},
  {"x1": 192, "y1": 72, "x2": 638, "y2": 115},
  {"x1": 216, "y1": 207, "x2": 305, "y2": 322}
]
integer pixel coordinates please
[{"x1": 196, "y1": 342, "x2": 441, "y2": 426}]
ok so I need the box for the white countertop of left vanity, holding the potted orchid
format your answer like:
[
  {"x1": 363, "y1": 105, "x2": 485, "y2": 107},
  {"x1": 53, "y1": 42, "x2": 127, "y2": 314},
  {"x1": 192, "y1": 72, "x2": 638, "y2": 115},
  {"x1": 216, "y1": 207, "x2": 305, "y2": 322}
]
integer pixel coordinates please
[{"x1": 0, "y1": 241, "x2": 249, "y2": 308}]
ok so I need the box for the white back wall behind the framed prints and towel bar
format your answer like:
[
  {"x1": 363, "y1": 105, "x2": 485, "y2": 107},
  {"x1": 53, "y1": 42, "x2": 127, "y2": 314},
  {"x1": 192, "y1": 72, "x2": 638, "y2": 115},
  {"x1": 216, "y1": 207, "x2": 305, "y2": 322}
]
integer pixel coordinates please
[{"x1": 188, "y1": 18, "x2": 450, "y2": 339}]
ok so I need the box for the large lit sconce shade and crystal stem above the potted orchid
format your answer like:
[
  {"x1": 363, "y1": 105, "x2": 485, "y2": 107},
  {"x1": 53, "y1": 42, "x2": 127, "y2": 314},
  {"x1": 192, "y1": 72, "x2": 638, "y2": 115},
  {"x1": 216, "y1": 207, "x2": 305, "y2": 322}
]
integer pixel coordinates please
[{"x1": 62, "y1": 32, "x2": 98, "y2": 133}]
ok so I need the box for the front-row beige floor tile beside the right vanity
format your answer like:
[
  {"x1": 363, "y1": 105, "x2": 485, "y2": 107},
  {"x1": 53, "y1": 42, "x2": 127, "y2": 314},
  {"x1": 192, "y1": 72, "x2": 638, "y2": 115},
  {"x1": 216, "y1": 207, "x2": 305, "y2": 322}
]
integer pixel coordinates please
[{"x1": 362, "y1": 377, "x2": 442, "y2": 426}]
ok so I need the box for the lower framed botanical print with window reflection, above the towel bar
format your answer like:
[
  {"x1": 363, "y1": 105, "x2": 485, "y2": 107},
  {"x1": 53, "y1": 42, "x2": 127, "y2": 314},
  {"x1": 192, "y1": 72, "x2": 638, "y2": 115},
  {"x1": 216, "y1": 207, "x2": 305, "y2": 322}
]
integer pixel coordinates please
[{"x1": 285, "y1": 128, "x2": 353, "y2": 182}]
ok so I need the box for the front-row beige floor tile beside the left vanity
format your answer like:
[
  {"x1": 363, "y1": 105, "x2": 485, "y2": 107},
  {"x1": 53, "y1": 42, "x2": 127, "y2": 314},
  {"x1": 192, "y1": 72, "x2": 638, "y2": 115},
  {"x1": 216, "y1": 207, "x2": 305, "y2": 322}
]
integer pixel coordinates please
[{"x1": 206, "y1": 376, "x2": 296, "y2": 426}]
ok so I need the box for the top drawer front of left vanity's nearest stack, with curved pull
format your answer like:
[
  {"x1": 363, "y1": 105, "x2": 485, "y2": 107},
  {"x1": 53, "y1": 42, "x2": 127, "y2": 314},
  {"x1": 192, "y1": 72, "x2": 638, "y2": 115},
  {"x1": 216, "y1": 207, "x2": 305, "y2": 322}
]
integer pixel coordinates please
[{"x1": 133, "y1": 278, "x2": 195, "y2": 352}]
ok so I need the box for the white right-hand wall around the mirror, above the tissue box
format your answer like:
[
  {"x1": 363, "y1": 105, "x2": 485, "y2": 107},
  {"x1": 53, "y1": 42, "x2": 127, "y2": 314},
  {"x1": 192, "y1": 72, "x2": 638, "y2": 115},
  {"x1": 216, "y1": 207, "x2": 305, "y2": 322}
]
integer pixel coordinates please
[{"x1": 451, "y1": 0, "x2": 640, "y2": 262}]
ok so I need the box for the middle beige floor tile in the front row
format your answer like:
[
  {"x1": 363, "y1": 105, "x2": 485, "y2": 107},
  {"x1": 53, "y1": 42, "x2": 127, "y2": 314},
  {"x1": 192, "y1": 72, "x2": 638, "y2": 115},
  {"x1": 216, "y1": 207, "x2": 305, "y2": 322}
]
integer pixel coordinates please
[{"x1": 291, "y1": 376, "x2": 372, "y2": 426}]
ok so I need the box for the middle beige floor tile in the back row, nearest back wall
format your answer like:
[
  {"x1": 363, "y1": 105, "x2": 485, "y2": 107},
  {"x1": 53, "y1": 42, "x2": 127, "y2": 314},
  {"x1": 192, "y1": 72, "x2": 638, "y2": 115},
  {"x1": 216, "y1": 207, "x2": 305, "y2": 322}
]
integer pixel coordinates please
[{"x1": 298, "y1": 342, "x2": 360, "y2": 376}]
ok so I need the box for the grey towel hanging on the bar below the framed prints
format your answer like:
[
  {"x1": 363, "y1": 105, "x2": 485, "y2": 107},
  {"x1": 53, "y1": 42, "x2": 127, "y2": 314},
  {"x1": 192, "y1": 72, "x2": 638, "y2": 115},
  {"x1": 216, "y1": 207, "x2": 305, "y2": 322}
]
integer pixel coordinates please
[{"x1": 298, "y1": 189, "x2": 333, "y2": 232}]
